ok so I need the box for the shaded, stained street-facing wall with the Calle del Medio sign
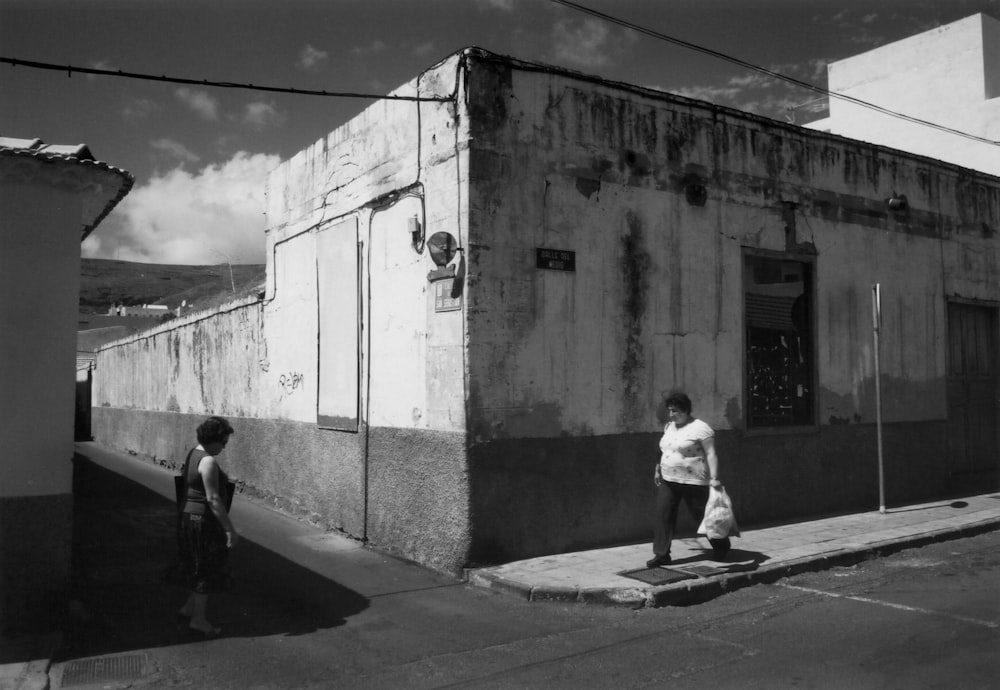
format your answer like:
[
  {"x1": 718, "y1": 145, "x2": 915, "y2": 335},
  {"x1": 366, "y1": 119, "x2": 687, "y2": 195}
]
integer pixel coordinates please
[{"x1": 460, "y1": 56, "x2": 1000, "y2": 560}]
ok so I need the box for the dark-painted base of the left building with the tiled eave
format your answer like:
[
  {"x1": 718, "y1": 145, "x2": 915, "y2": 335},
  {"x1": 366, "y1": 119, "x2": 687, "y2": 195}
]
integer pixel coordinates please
[{"x1": 0, "y1": 492, "x2": 73, "y2": 633}]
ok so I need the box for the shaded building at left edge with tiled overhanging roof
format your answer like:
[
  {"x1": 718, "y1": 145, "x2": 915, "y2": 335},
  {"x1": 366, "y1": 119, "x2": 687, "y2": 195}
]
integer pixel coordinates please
[{"x1": 0, "y1": 137, "x2": 133, "y2": 635}]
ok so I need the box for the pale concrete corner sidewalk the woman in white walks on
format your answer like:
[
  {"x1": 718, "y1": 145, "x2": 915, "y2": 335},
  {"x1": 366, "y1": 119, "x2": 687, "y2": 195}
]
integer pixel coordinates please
[{"x1": 467, "y1": 493, "x2": 1000, "y2": 608}]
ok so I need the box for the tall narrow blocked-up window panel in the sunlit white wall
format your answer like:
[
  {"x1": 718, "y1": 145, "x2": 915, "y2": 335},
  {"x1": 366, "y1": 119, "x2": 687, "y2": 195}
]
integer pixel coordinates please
[{"x1": 316, "y1": 217, "x2": 360, "y2": 431}]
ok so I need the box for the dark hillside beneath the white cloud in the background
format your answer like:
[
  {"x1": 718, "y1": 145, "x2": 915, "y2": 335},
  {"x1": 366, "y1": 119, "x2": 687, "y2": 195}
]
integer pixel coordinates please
[{"x1": 80, "y1": 259, "x2": 265, "y2": 314}]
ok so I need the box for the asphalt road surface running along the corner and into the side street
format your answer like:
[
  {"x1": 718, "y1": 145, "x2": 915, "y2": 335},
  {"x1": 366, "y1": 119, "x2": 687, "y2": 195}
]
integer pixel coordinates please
[{"x1": 53, "y1": 452, "x2": 1000, "y2": 690}]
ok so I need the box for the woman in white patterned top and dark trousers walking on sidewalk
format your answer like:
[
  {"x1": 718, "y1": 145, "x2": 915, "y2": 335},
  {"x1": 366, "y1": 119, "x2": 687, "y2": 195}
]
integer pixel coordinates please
[{"x1": 646, "y1": 392, "x2": 730, "y2": 568}]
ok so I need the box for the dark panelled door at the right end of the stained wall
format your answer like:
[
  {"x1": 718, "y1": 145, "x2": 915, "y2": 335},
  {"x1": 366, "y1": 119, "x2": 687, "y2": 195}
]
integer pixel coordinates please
[{"x1": 948, "y1": 302, "x2": 1000, "y2": 484}]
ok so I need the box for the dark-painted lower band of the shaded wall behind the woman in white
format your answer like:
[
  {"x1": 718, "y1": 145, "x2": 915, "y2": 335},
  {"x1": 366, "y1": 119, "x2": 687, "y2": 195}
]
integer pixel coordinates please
[{"x1": 470, "y1": 422, "x2": 998, "y2": 564}]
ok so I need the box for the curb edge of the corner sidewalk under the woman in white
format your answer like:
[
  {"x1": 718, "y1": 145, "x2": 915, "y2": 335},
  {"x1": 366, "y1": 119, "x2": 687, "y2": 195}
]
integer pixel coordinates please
[{"x1": 466, "y1": 518, "x2": 1000, "y2": 609}]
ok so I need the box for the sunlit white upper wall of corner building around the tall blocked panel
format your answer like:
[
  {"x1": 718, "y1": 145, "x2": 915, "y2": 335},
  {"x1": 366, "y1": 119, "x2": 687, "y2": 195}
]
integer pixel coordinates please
[{"x1": 262, "y1": 56, "x2": 467, "y2": 431}]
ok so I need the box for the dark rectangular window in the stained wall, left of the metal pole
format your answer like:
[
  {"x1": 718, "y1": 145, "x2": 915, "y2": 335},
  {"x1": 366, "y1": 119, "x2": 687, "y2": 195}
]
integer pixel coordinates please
[{"x1": 743, "y1": 254, "x2": 815, "y2": 428}]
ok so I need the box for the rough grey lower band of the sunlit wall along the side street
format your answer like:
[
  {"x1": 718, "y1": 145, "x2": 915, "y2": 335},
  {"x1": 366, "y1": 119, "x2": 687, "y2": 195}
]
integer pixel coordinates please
[{"x1": 92, "y1": 407, "x2": 469, "y2": 573}]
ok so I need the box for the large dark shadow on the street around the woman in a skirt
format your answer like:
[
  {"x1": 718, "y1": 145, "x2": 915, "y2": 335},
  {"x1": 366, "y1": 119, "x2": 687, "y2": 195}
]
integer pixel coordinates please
[{"x1": 57, "y1": 456, "x2": 368, "y2": 661}]
